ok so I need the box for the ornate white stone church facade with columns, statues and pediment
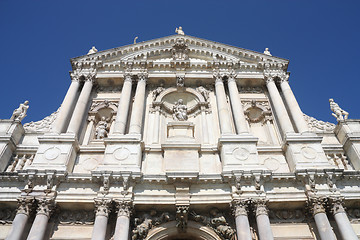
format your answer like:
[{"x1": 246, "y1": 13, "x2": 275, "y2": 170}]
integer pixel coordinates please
[{"x1": 0, "y1": 27, "x2": 360, "y2": 240}]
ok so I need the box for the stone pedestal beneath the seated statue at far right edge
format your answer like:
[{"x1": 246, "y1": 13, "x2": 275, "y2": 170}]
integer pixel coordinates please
[{"x1": 335, "y1": 119, "x2": 360, "y2": 170}]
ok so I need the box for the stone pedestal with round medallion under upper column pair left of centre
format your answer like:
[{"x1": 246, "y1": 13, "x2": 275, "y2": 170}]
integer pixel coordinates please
[{"x1": 96, "y1": 134, "x2": 143, "y2": 173}]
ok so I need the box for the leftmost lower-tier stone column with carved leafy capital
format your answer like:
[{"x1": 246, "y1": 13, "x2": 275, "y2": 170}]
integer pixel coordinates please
[{"x1": 5, "y1": 197, "x2": 34, "y2": 240}]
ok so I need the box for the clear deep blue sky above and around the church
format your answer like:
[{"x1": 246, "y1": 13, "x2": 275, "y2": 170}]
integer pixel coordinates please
[{"x1": 0, "y1": 0, "x2": 360, "y2": 123}]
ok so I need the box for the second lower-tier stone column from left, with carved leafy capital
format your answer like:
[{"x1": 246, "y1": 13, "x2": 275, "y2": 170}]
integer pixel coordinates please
[{"x1": 27, "y1": 198, "x2": 54, "y2": 240}]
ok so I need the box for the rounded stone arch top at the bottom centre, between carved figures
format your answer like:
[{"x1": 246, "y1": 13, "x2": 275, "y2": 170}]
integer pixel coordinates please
[{"x1": 145, "y1": 221, "x2": 221, "y2": 240}]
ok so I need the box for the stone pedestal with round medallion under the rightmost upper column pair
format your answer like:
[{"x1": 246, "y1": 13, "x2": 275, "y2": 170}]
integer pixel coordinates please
[{"x1": 284, "y1": 133, "x2": 334, "y2": 171}]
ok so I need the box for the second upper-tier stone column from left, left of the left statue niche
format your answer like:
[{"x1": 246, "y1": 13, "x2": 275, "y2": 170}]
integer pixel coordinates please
[{"x1": 67, "y1": 74, "x2": 94, "y2": 135}]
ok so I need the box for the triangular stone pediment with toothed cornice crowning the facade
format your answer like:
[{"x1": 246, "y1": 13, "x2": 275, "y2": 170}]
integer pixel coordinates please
[{"x1": 71, "y1": 35, "x2": 289, "y2": 70}]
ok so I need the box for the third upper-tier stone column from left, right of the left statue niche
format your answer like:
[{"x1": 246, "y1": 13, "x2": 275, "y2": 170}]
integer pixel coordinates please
[{"x1": 114, "y1": 73, "x2": 132, "y2": 134}]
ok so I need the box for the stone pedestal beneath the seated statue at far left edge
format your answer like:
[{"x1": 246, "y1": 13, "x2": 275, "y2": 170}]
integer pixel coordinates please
[{"x1": 0, "y1": 120, "x2": 25, "y2": 172}]
